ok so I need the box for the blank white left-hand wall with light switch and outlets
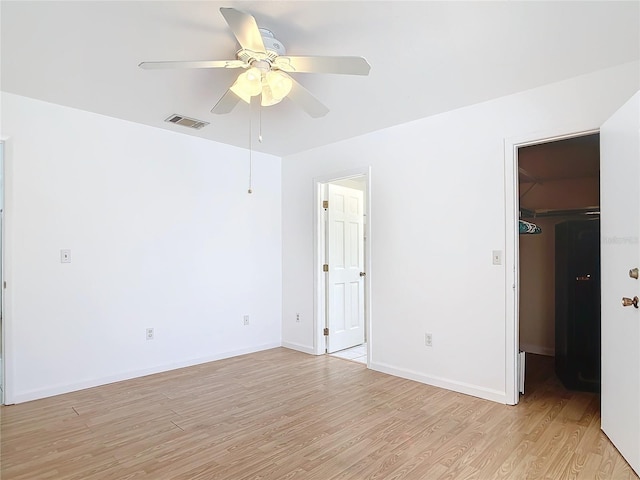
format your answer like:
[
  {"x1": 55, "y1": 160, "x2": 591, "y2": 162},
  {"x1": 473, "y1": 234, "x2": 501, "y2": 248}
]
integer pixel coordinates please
[{"x1": 0, "y1": 94, "x2": 282, "y2": 402}]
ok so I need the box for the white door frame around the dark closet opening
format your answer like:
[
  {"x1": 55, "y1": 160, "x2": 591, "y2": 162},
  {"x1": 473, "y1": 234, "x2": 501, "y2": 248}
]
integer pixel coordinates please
[{"x1": 504, "y1": 127, "x2": 600, "y2": 405}]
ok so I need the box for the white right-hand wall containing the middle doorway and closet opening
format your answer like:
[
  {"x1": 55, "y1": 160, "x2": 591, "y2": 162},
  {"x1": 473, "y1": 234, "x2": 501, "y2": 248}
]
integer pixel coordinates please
[{"x1": 282, "y1": 62, "x2": 639, "y2": 403}]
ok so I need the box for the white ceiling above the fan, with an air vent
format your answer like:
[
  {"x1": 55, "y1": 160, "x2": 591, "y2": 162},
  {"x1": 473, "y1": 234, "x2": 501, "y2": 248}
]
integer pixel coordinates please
[{"x1": 0, "y1": 0, "x2": 640, "y2": 156}]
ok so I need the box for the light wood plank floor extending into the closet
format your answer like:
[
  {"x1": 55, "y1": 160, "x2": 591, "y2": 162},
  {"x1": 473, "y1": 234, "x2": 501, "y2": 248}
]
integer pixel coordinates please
[{"x1": 0, "y1": 348, "x2": 638, "y2": 480}]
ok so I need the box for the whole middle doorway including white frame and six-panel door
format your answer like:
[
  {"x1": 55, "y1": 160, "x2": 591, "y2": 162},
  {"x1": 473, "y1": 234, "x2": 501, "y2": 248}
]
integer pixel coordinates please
[{"x1": 314, "y1": 167, "x2": 372, "y2": 364}]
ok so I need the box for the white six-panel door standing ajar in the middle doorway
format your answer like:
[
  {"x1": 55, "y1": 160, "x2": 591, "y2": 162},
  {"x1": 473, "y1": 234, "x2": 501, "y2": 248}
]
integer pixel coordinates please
[{"x1": 327, "y1": 183, "x2": 365, "y2": 353}]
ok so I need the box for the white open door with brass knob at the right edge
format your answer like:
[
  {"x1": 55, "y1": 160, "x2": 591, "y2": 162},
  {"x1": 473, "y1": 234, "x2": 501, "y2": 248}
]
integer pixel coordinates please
[{"x1": 600, "y1": 92, "x2": 640, "y2": 474}]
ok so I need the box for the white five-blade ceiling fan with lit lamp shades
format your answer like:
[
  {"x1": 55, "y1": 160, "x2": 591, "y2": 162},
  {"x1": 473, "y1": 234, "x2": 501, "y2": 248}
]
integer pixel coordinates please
[{"x1": 139, "y1": 7, "x2": 371, "y2": 118}]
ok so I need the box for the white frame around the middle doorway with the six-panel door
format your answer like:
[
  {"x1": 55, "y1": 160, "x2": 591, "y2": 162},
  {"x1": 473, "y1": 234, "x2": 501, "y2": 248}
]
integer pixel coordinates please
[{"x1": 313, "y1": 167, "x2": 373, "y2": 367}]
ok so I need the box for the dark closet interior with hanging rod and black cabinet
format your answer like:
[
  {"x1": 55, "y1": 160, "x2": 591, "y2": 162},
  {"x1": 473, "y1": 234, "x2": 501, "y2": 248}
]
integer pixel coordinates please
[{"x1": 517, "y1": 133, "x2": 600, "y2": 393}]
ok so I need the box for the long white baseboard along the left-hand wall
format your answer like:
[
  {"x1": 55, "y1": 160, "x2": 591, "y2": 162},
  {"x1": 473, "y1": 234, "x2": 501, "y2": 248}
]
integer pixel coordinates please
[{"x1": 5, "y1": 343, "x2": 281, "y2": 404}]
